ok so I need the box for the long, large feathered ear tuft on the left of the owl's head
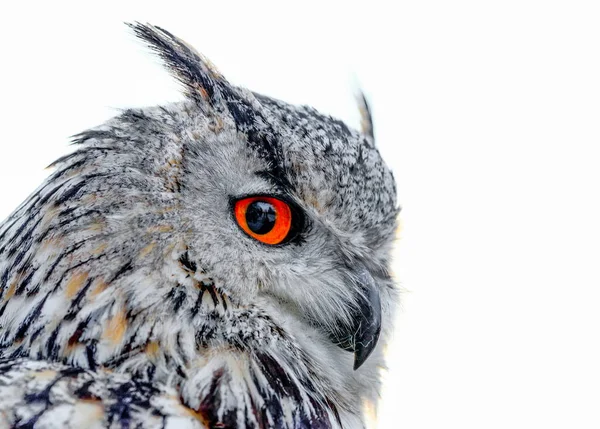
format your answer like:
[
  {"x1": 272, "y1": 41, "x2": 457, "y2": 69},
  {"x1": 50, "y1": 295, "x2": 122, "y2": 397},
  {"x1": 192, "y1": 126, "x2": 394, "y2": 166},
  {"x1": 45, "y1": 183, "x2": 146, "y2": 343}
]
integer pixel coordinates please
[{"x1": 126, "y1": 22, "x2": 229, "y2": 107}]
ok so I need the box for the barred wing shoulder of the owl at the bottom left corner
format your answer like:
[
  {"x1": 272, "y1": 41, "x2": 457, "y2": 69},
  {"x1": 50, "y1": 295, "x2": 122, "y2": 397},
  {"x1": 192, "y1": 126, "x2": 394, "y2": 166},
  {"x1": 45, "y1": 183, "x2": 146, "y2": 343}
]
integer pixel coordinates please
[{"x1": 0, "y1": 359, "x2": 204, "y2": 429}]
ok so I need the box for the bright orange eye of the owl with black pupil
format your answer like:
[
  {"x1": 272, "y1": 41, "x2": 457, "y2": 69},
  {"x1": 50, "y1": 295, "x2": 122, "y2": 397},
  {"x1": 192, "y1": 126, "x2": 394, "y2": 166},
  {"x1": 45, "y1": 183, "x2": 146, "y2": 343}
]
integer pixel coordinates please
[{"x1": 233, "y1": 196, "x2": 292, "y2": 244}]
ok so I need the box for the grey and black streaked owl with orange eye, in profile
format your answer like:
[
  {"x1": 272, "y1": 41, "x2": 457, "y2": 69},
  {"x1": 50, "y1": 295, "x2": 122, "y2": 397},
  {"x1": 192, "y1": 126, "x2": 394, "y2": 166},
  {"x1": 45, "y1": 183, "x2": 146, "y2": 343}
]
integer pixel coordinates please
[{"x1": 0, "y1": 23, "x2": 399, "y2": 429}]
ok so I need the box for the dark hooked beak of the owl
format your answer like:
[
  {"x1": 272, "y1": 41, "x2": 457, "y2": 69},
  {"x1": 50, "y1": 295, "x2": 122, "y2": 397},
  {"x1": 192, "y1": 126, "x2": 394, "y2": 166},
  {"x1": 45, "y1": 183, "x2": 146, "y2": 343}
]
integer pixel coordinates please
[{"x1": 332, "y1": 263, "x2": 381, "y2": 370}]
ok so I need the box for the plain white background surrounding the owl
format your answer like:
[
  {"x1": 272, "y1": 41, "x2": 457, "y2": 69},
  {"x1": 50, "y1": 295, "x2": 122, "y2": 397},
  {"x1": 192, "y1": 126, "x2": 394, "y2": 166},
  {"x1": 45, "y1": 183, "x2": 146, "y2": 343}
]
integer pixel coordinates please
[{"x1": 0, "y1": 0, "x2": 600, "y2": 429}]
